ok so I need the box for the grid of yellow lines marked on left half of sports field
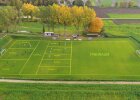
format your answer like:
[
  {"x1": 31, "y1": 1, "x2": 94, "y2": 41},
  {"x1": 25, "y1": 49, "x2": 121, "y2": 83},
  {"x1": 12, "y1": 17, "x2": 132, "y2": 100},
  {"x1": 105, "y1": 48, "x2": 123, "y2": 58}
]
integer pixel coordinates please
[{"x1": 1, "y1": 40, "x2": 72, "y2": 75}]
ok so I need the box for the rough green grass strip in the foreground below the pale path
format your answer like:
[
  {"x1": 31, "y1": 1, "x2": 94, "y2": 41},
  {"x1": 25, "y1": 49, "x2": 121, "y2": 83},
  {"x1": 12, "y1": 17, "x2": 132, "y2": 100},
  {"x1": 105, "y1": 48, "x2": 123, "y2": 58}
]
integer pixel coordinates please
[{"x1": 0, "y1": 83, "x2": 140, "y2": 100}]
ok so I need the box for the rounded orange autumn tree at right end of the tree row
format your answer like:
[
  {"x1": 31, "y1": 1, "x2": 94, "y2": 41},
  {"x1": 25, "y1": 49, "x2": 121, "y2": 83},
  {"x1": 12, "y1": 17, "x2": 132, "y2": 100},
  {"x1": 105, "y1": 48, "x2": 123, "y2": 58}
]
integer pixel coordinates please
[{"x1": 88, "y1": 17, "x2": 104, "y2": 33}]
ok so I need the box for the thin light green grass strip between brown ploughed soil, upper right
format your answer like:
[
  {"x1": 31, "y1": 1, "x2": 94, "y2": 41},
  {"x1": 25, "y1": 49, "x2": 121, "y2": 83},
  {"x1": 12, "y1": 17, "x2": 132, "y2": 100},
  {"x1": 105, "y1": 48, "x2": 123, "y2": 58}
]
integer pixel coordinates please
[{"x1": 108, "y1": 13, "x2": 140, "y2": 19}]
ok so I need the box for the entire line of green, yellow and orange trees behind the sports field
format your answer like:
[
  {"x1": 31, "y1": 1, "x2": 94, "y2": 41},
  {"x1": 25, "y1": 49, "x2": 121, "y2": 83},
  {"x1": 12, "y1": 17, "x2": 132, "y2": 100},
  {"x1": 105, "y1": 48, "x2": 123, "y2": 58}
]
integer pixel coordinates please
[{"x1": 0, "y1": 0, "x2": 103, "y2": 33}]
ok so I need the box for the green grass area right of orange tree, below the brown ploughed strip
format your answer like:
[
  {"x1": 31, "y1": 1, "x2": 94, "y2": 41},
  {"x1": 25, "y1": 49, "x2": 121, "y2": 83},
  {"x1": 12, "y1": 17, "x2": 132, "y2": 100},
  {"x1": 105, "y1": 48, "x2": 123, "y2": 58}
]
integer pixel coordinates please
[{"x1": 104, "y1": 20, "x2": 140, "y2": 40}]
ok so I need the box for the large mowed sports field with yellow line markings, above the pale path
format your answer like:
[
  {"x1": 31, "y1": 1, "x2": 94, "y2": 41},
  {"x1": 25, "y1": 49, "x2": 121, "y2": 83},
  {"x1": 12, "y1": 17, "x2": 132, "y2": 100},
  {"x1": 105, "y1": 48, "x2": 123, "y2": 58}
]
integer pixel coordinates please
[{"x1": 0, "y1": 38, "x2": 140, "y2": 80}]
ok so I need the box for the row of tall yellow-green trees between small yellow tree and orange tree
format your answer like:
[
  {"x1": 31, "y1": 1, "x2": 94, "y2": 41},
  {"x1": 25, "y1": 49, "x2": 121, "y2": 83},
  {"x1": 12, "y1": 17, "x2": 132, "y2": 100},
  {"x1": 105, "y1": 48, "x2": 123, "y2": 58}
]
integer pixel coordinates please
[{"x1": 39, "y1": 4, "x2": 96, "y2": 31}]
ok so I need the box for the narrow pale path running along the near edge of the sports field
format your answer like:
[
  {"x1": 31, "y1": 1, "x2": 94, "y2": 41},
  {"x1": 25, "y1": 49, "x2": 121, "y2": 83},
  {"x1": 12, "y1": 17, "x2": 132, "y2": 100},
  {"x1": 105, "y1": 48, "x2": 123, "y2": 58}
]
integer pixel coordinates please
[{"x1": 0, "y1": 79, "x2": 140, "y2": 85}]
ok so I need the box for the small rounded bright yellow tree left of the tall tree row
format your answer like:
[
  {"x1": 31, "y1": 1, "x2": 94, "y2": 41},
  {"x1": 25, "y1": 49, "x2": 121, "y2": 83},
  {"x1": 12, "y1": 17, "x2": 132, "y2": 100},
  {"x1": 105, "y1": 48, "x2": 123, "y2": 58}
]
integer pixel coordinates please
[{"x1": 22, "y1": 3, "x2": 39, "y2": 18}]
